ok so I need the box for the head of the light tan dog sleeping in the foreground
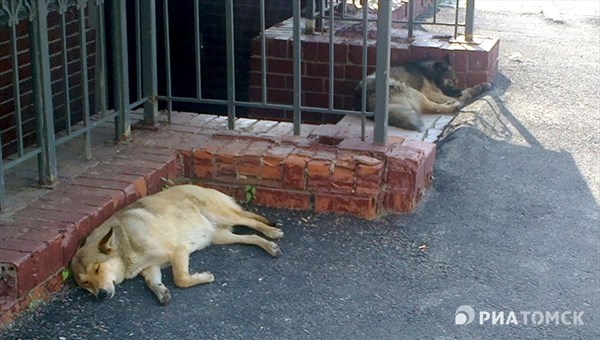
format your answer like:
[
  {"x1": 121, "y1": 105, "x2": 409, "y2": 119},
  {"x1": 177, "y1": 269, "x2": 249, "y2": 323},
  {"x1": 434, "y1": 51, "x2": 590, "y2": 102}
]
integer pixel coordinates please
[{"x1": 71, "y1": 228, "x2": 123, "y2": 299}]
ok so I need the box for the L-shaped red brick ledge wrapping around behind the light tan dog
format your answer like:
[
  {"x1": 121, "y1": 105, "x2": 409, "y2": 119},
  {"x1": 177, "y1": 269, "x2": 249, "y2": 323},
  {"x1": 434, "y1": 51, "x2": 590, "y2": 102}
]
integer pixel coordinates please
[{"x1": 0, "y1": 113, "x2": 435, "y2": 325}]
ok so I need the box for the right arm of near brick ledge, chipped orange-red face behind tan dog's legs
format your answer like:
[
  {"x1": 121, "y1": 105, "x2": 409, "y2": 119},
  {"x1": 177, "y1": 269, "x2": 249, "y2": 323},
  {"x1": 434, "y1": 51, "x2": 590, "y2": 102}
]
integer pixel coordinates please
[{"x1": 182, "y1": 125, "x2": 435, "y2": 218}]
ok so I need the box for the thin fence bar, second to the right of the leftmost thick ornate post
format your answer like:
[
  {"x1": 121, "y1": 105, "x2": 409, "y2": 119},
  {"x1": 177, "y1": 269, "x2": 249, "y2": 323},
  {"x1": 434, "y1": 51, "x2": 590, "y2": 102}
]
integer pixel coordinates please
[{"x1": 77, "y1": 0, "x2": 92, "y2": 160}]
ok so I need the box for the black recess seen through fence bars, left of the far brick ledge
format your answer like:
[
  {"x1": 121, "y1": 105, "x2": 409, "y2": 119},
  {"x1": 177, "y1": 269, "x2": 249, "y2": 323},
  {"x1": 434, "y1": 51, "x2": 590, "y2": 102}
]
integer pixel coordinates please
[{"x1": 158, "y1": 0, "x2": 300, "y2": 116}]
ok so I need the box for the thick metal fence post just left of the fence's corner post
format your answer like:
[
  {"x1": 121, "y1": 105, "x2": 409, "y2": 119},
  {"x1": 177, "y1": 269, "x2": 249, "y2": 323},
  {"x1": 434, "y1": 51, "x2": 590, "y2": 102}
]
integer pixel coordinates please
[{"x1": 111, "y1": 0, "x2": 131, "y2": 141}]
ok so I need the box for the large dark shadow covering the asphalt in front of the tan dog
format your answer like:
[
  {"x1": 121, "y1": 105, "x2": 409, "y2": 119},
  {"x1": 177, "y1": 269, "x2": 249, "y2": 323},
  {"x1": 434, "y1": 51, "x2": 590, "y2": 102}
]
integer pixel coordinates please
[{"x1": 0, "y1": 79, "x2": 600, "y2": 339}]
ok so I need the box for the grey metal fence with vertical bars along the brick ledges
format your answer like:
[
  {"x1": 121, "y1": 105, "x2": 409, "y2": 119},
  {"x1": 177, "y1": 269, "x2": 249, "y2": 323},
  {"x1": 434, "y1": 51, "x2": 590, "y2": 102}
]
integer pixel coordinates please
[{"x1": 0, "y1": 0, "x2": 473, "y2": 208}]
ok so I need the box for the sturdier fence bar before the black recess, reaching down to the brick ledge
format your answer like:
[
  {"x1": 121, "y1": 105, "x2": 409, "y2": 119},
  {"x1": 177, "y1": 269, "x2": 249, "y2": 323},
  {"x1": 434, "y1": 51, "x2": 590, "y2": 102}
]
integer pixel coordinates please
[{"x1": 225, "y1": 0, "x2": 235, "y2": 130}]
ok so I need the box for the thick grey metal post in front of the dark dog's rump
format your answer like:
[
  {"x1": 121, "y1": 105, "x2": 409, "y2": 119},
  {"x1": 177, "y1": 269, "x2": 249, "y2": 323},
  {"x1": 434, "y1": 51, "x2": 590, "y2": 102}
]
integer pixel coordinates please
[{"x1": 374, "y1": 1, "x2": 392, "y2": 144}]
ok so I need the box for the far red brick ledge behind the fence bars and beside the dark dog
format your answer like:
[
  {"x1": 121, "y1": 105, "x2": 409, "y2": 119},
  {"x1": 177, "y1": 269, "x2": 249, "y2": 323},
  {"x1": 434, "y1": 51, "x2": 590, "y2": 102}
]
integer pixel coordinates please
[{"x1": 248, "y1": 0, "x2": 499, "y2": 123}]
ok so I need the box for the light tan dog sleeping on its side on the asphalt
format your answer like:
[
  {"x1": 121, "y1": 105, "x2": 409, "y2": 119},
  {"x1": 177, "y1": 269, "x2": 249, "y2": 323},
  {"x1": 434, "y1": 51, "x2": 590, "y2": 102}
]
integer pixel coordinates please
[{"x1": 71, "y1": 185, "x2": 283, "y2": 303}]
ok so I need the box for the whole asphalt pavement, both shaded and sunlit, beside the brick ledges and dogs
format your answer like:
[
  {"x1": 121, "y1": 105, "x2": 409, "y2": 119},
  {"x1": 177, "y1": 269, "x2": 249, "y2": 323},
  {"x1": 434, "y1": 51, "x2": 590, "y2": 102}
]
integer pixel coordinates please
[{"x1": 0, "y1": 2, "x2": 600, "y2": 339}]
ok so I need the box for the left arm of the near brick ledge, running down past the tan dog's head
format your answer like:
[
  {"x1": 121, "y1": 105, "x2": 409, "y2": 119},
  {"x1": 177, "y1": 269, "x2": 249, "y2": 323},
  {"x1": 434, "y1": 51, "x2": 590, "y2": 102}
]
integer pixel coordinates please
[{"x1": 0, "y1": 147, "x2": 181, "y2": 326}]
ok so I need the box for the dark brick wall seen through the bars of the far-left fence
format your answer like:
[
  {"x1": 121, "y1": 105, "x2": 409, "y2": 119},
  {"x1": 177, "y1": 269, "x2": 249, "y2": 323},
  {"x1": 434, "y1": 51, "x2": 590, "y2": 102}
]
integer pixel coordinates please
[{"x1": 0, "y1": 6, "x2": 95, "y2": 157}]
